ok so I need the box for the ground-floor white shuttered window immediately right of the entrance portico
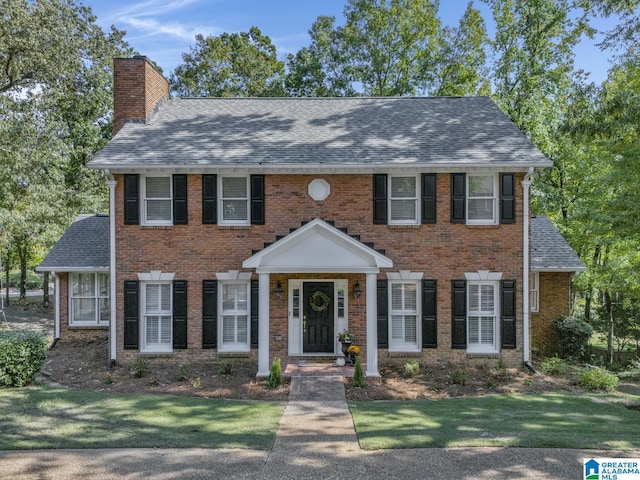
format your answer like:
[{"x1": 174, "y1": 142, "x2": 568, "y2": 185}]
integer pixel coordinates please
[{"x1": 389, "y1": 282, "x2": 419, "y2": 351}]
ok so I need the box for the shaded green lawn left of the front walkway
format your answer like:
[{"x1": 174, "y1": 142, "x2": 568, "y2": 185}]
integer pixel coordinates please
[{"x1": 0, "y1": 386, "x2": 284, "y2": 450}]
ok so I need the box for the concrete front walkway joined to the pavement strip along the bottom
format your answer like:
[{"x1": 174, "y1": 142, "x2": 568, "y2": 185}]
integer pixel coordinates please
[{"x1": 0, "y1": 372, "x2": 640, "y2": 480}]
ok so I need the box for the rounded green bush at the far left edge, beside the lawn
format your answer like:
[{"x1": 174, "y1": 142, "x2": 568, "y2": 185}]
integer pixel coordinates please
[{"x1": 0, "y1": 330, "x2": 47, "y2": 387}]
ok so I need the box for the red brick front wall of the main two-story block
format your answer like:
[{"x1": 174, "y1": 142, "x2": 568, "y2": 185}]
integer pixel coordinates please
[{"x1": 116, "y1": 174, "x2": 522, "y2": 364}]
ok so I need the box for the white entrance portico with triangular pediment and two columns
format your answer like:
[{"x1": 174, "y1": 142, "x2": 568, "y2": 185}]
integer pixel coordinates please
[{"x1": 242, "y1": 219, "x2": 393, "y2": 376}]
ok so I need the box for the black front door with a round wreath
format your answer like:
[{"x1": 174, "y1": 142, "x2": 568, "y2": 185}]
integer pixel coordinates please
[{"x1": 302, "y1": 282, "x2": 334, "y2": 353}]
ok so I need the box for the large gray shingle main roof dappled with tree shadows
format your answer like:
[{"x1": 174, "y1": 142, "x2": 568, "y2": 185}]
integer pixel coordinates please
[{"x1": 89, "y1": 97, "x2": 551, "y2": 171}]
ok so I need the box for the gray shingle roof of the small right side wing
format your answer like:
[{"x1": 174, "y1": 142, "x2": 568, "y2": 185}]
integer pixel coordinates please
[{"x1": 530, "y1": 216, "x2": 587, "y2": 272}]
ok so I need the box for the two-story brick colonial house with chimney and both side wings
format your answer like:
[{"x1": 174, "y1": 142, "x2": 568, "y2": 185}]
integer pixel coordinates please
[{"x1": 39, "y1": 57, "x2": 584, "y2": 376}]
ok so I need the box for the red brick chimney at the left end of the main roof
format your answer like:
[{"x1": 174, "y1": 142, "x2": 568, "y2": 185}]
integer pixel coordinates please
[{"x1": 113, "y1": 56, "x2": 169, "y2": 135}]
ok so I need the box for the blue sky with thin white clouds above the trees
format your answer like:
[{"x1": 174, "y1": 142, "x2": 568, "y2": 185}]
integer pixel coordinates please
[{"x1": 82, "y1": 0, "x2": 615, "y2": 83}]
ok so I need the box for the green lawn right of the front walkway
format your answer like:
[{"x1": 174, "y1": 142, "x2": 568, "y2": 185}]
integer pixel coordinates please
[{"x1": 349, "y1": 394, "x2": 640, "y2": 450}]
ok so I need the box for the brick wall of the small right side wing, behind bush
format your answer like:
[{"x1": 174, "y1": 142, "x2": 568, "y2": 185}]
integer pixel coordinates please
[{"x1": 531, "y1": 272, "x2": 571, "y2": 355}]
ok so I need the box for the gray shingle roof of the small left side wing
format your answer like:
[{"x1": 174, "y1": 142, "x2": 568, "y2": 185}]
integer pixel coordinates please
[{"x1": 36, "y1": 215, "x2": 109, "y2": 272}]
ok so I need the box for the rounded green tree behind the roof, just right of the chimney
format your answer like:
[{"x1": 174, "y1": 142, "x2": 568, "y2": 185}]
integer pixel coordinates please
[{"x1": 170, "y1": 27, "x2": 284, "y2": 97}]
